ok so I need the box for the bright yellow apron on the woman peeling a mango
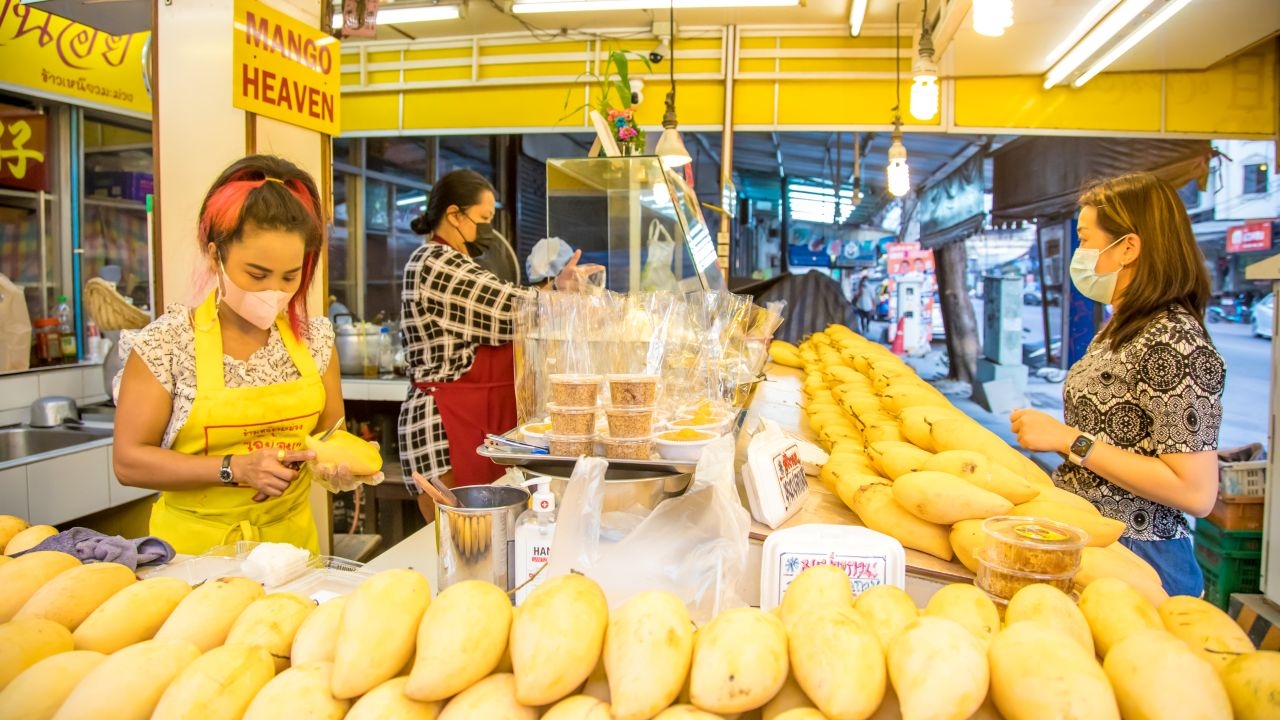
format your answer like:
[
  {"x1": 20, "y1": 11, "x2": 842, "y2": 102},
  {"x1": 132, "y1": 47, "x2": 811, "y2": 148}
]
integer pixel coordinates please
[{"x1": 151, "y1": 293, "x2": 325, "y2": 555}]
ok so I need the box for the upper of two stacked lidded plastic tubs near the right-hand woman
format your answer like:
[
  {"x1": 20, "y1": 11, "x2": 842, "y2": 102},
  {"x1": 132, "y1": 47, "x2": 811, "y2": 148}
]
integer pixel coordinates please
[{"x1": 982, "y1": 515, "x2": 1089, "y2": 577}]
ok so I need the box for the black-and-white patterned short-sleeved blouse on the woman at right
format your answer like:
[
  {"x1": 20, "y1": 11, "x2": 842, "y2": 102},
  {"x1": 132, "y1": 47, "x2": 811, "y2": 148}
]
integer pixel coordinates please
[{"x1": 1053, "y1": 305, "x2": 1226, "y2": 541}]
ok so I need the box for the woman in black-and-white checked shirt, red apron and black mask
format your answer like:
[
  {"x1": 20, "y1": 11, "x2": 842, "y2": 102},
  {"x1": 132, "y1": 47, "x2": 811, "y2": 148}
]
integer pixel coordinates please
[{"x1": 398, "y1": 170, "x2": 588, "y2": 521}]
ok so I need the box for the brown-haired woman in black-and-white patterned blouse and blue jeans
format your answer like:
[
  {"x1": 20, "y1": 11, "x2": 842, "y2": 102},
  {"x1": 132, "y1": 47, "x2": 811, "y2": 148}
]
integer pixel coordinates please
[{"x1": 1010, "y1": 173, "x2": 1226, "y2": 596}]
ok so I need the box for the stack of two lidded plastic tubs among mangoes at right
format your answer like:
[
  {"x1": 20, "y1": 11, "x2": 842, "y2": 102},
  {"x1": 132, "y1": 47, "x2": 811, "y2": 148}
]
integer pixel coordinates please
[{"x1": 974, "y1": 515, "x2": 1089, "y2": 607}]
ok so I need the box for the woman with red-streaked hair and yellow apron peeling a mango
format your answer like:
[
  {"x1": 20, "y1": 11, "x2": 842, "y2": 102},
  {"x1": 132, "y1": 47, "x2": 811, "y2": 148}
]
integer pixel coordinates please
[{"x1": 114, "y1": 155, "x2": 349, "y2": 553}]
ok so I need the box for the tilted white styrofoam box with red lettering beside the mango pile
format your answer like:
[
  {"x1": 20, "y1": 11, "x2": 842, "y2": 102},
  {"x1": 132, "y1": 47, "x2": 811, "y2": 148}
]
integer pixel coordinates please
[{"x1": 737, "y1": 434, "x2": 809, "y2": 528}]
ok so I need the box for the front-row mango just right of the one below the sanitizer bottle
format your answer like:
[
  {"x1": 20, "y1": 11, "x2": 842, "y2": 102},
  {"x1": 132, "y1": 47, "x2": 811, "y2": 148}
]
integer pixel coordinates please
[{"x1": 604, "y1": 589, "x2": 696, "y2": 720}]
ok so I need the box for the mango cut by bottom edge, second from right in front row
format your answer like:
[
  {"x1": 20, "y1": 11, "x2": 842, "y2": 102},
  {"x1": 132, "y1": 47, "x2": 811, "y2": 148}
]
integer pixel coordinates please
[{"x1": 1102, "y1": 629, "x2": 1231, "y2": 720}]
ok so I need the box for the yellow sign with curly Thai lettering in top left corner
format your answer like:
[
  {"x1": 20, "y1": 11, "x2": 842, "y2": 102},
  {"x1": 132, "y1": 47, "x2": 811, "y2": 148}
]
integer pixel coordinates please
[{"x1": 0, "y1": 0, "x2": 151, "y2": 117}]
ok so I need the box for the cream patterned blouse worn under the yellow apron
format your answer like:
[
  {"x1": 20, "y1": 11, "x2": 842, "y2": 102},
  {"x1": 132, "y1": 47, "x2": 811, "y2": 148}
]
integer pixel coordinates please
[{"x1": 111, "y1": 304, "x2": 334, "y2": 447}]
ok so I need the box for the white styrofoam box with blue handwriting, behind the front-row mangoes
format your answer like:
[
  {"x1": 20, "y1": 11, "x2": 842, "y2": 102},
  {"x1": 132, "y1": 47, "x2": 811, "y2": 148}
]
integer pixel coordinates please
[{"x1": 760, "y1": 523, "x2": 906, "y2": 610}]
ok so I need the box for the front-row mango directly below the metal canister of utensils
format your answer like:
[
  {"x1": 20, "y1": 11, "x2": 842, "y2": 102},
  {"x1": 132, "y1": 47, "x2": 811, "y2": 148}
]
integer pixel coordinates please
[{"x1": 404, "y1": 580, "x2": 512, "y2": 702}]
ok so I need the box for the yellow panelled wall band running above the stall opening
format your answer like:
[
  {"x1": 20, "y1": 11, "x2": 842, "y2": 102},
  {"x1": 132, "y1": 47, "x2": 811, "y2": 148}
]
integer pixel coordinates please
[{"x1": 342, "y1": 35, "x2": 1277, "y2": 138}]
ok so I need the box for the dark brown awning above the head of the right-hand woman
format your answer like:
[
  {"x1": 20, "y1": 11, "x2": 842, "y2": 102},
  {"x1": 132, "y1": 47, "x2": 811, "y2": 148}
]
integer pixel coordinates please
[{"x1": 992, "y1": 136, "x2": 1212, "y2": 223}]
